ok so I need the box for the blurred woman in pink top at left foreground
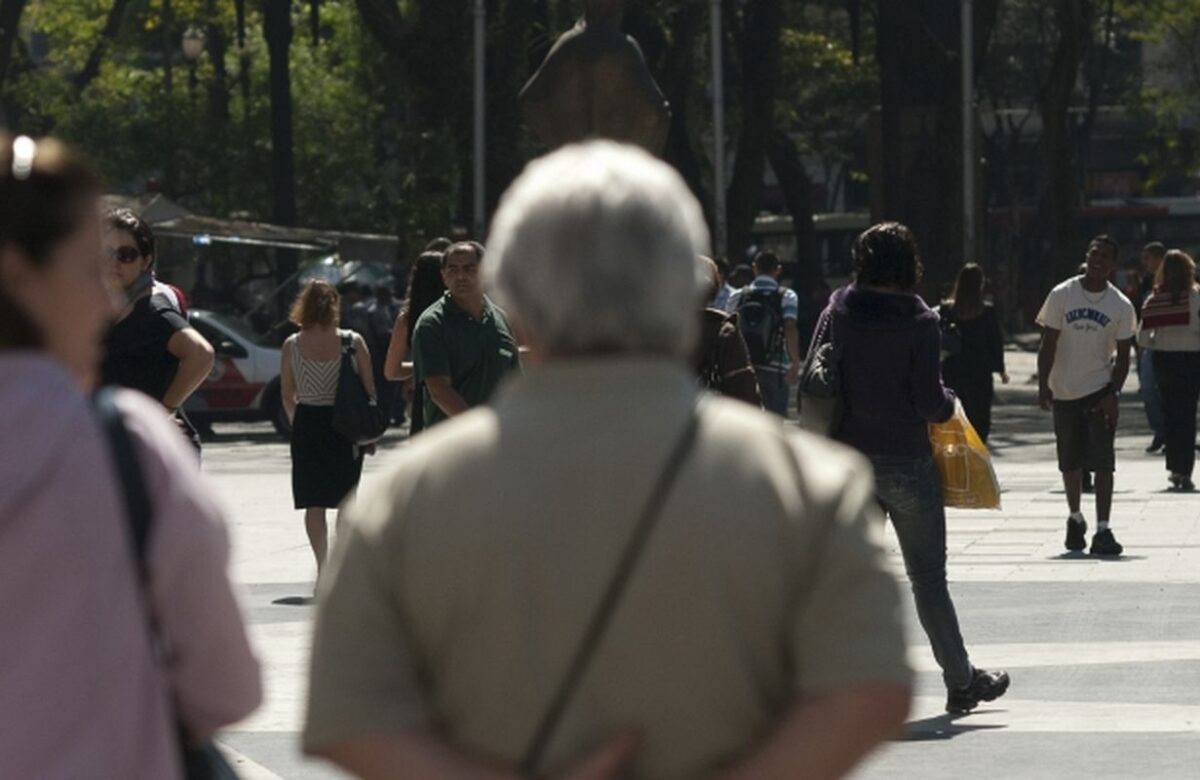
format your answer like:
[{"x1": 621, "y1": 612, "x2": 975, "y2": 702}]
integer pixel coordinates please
[{"x1": 0, "y1": 136, "x2": 262, "y2": 780}]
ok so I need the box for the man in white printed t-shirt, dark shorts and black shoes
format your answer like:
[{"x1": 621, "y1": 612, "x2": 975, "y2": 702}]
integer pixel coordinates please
[{"x1": 1038, "y1": 235, "x2": 1135, "y2": 556}]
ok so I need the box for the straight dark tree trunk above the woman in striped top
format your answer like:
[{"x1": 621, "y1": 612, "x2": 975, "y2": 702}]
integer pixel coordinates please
[{"x1": 263, "y1": 0, "x2": 296, "y2": 283}]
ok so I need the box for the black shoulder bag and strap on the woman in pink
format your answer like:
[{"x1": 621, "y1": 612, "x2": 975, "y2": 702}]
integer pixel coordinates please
[{"x1": 95, "y1": 388, "x2": 238, "y2": 780}]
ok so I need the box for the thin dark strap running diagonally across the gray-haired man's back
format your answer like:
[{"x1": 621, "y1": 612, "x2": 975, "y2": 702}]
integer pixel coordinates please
[{"x1": 521, "y1": 408, "x2": 700, "y2": 776}]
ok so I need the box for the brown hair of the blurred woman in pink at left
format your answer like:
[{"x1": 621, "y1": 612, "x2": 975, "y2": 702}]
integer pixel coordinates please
[{"x1": 0, "y1": 133, "x2": 100, "y2": 349}]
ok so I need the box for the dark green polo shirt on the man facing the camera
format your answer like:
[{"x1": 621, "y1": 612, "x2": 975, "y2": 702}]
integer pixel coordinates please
[{"x1": 413, "y1": 293, "x2": 521, "y2": 426}]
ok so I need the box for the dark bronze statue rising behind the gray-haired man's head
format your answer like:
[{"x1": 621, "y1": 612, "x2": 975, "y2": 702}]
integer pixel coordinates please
[{"x1": 521, "y1": 0, "x2": 671, "y2": 155}]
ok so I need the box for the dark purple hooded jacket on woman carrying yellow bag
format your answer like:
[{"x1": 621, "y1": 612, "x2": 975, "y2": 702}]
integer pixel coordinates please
[{"x1": 810, "y1": 284, "x2": 954, "y2": 457}]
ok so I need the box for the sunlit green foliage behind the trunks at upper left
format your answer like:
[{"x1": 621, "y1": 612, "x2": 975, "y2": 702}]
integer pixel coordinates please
[{"x1": 5, "y1": 0, "x2": 452, "y2": 242}]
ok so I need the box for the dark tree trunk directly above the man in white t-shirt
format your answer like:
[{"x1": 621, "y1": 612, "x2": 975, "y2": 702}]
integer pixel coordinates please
[{"x1": 1038, "y1": 0, "x2": 1087, "y2": 288}]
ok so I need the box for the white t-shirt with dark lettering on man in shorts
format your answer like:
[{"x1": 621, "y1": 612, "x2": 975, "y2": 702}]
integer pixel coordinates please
[{"x1": 1038, "y1": 276, "x2": 1135, "y2": 401}]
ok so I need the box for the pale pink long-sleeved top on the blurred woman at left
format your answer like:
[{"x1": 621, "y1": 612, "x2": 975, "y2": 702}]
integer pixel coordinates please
[{"x1": 0, "y1": 352, "x2": 262, "y2": 780}]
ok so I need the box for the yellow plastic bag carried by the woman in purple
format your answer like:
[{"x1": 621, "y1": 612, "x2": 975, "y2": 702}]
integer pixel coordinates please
[{"x1": 929, "y1": 401, "x2": 1000, "y2": 509}]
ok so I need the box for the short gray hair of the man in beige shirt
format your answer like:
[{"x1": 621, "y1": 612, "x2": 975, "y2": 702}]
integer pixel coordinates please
[{"x1": 484, "y1": 140, "x2": 708, "y2": 358}]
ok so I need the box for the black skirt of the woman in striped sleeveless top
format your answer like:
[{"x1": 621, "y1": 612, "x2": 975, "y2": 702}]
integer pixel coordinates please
[{"x1": 292, "y1": 403, "x2": 362, "y2": 509}]
